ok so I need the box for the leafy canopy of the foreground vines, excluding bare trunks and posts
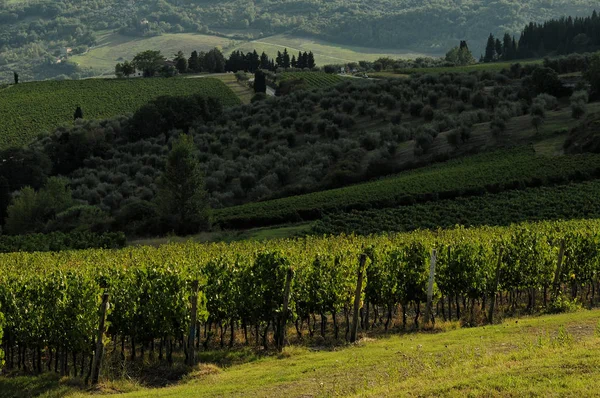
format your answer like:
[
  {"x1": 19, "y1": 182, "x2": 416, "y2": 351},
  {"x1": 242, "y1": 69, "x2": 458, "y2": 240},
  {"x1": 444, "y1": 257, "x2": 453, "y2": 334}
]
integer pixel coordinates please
[{"x1": 0, "y1": 220, "x2": 600, "y2": 361}]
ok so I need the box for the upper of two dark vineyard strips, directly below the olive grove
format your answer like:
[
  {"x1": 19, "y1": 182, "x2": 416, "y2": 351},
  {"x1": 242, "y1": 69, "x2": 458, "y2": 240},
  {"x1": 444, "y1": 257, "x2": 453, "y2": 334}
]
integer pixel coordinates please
[{"x1": 215, "y1": 150, "x2": 600, "y2": 228}]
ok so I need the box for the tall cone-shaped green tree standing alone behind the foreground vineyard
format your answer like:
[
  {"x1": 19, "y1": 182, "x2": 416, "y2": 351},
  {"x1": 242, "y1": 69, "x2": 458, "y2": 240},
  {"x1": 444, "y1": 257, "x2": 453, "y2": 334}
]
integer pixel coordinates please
[{"x1": 157, "y1": 135, "x2": 210, "y2": 234}]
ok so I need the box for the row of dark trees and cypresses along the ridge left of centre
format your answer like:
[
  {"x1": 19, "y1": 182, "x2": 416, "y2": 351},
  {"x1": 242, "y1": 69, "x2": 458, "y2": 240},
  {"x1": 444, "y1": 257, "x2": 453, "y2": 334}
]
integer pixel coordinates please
[{"x1": 115, "y1": 48, "x2": 316, "y2": 77}]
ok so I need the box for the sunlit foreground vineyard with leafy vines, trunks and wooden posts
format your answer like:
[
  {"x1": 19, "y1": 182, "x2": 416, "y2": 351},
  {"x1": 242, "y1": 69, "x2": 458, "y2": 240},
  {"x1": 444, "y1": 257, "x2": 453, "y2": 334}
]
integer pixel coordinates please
[{"x1": 0, "y1": 220, "x2": 600, "y2": 378}]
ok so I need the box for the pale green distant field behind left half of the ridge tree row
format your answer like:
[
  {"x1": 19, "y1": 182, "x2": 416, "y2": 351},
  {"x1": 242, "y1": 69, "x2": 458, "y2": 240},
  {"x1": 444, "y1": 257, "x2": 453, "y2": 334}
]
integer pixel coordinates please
[{"x1": 71, "y1": 31, "x2": 234, "y2": 76}]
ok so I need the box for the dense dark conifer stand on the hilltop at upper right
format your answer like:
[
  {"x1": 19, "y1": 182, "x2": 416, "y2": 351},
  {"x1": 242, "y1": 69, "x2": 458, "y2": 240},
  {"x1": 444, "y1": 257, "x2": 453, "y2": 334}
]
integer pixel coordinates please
[{"x1": 481, "y1": 10, "x2": 600, "y2": 62}]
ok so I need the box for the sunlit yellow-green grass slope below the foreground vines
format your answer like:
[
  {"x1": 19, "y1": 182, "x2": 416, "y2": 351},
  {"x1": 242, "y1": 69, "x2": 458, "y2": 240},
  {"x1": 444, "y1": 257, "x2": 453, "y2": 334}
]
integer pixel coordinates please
[{"x1": 0, "y1": 310, "x2": 600, "y2": 398}]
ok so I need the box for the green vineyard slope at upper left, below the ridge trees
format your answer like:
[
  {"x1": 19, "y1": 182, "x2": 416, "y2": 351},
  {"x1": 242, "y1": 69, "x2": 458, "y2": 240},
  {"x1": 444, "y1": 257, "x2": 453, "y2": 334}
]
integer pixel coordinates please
[{"x1": 0, "y1": 78, "x2": 240, "y2": 149}]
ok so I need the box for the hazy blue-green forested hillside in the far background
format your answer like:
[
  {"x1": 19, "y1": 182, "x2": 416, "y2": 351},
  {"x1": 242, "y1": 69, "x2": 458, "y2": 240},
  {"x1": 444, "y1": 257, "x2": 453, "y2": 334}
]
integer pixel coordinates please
[{"x1": 0, "y1": 0, "x2": 597, "y2": 78}]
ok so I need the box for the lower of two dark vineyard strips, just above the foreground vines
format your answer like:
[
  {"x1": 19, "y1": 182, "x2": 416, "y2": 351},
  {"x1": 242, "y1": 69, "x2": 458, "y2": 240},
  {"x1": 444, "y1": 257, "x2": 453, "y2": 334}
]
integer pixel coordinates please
[{"x1": 311, "y1": 180, "x2": 600, "y2": 235}]
